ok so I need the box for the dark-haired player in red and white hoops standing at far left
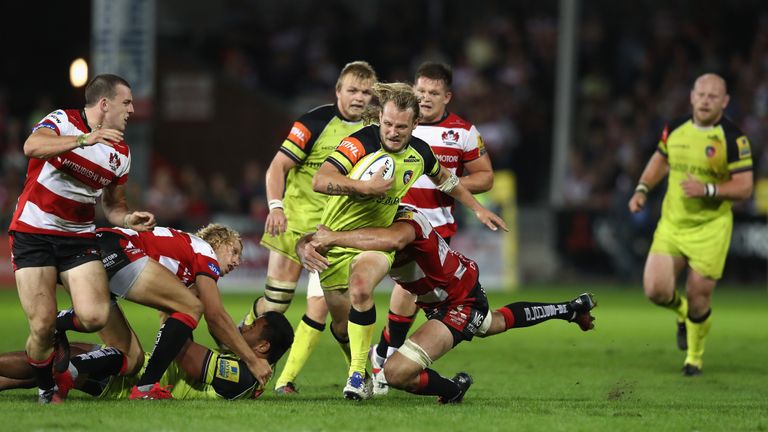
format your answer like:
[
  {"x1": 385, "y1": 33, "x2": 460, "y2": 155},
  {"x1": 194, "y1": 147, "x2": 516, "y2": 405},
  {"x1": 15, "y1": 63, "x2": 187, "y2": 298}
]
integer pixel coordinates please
[{"x1": 8, "y1": 74, "x2": 155, "y2": 403}]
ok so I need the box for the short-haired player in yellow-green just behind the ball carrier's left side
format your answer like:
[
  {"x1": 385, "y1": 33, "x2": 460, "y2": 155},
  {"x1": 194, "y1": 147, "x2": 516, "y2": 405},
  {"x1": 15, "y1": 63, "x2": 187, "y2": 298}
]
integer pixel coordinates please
[{"x1": 243, "y1": 61, "x2": 377, "y2": 393}]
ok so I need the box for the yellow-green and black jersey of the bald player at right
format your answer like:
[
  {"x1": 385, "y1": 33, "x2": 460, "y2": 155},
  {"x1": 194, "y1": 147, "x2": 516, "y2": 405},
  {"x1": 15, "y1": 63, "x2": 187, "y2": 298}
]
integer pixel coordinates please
[{"x1": 658, "y1": 116, "x2": 752, "y2": 228}]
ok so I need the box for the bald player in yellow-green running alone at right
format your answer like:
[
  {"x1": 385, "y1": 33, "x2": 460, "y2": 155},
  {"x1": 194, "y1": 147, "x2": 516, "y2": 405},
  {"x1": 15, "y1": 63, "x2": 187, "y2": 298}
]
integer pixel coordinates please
[{"x1": 629, "y1": 73, "x2": 754, "y2": 376}]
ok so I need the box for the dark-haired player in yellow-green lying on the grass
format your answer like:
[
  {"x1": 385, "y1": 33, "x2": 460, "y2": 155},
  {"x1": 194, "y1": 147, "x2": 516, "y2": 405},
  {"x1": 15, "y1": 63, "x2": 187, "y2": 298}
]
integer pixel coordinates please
[{"x1": 0, "y1": 312, "x2": 293, "y2": 399}]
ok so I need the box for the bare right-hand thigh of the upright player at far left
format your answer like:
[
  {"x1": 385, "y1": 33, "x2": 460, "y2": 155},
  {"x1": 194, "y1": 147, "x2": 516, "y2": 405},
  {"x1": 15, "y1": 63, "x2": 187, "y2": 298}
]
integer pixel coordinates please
[{"x1": 61, "y1": 261, "x2": 110, "y2": 321}]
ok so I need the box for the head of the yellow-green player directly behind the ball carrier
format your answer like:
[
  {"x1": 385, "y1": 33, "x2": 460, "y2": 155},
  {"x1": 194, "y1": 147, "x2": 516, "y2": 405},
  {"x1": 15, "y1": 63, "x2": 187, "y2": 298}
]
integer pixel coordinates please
[{"x1": 336, "y1": 61, "x2": 378, "y2": 121}]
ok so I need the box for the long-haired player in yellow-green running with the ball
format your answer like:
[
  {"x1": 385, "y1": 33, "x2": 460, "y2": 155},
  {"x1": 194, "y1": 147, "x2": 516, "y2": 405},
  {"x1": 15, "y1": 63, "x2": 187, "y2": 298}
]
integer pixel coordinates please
[{"x1": 312, "y1": 83, "x2": 507, "y2": 400}]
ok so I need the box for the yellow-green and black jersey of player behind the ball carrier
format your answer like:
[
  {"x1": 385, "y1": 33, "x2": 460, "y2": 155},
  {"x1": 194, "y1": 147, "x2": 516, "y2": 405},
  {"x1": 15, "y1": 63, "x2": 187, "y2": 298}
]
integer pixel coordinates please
[{"x1": 280, "y1": 104, "x2": 364, "y2": 234}]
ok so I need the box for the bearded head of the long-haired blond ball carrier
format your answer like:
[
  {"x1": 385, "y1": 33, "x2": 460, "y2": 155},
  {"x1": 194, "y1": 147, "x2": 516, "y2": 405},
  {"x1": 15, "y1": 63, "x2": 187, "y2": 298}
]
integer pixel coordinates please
[{"x1": 373, "y1": 83, "x2": 421, "y2": 152}]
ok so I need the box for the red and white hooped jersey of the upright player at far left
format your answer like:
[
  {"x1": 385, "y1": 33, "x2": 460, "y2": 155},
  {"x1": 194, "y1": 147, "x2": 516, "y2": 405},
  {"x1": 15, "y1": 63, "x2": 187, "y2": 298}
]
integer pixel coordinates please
[{"x1": 8, "y1": 110, "x2": 131, "y2": 236}]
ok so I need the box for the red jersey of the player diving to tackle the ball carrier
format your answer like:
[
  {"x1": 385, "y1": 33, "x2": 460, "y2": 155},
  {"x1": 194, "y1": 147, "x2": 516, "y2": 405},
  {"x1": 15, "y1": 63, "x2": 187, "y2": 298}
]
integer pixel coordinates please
[{"x1": 389, "y1": 206, "x2": 479, "y2": 308}]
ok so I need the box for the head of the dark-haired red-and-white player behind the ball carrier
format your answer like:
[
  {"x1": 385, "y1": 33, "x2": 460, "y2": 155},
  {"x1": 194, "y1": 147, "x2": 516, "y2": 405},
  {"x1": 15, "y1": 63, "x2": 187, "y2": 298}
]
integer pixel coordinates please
[{"x1": 413, "y1": 62, "x2": 453, "y2": 123}]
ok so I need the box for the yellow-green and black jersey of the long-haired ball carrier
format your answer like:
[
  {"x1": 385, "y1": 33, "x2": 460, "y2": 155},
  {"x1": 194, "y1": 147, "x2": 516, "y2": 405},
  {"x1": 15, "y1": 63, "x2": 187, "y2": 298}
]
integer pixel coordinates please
[{"x1": 321, "y1": 125, "x2": 440, "y2": 231}]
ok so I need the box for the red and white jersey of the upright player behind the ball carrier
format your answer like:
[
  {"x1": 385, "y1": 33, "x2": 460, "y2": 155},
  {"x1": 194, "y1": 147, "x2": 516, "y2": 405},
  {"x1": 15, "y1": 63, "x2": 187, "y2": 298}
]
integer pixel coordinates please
[{"x1": 402, "y1": 113, "x2": 485, "y2": 238}]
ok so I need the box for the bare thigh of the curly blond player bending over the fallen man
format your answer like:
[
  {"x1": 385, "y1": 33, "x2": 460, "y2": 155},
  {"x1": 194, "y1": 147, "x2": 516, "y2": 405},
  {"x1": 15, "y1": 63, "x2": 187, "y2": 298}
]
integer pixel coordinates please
[{"x1": 125, "y1": 259, "x2": 203, "y2": 318}]
